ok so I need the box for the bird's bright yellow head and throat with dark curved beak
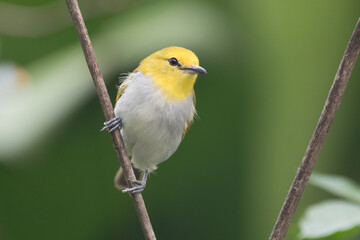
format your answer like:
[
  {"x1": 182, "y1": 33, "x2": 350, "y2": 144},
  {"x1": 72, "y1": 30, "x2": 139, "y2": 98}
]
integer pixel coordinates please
[{"x1": 135, "y1": 47, "x2": 206, "y2": 101}]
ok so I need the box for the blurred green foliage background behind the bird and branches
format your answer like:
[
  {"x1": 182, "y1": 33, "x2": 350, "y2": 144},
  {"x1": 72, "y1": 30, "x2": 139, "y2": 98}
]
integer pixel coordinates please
[{"x1": 0, "y1": 0, "x2": 360, "y2": 240}]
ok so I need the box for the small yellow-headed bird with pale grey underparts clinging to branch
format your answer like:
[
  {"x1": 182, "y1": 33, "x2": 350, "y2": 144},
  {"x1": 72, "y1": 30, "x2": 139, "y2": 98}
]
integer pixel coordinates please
[{"x1": 102, "y1": 47, "x2": 207, "y2": 193}]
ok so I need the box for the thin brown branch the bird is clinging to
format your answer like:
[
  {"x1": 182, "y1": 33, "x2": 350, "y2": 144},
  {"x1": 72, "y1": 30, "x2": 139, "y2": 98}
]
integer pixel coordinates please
[{"x1": 66, "y1": 0, "x2": 156, "y2": 239}]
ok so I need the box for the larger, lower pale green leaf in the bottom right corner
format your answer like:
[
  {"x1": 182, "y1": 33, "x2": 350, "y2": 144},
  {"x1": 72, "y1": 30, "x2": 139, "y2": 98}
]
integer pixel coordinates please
[{"x1": 299, "y1": 200, "x2": 360, "y2": 239}]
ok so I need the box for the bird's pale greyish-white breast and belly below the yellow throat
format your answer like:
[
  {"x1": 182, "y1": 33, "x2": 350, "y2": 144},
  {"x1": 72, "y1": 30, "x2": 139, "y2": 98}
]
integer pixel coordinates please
[{"x1": 115, "y1": 72, "x2": 195, "y2": 171}]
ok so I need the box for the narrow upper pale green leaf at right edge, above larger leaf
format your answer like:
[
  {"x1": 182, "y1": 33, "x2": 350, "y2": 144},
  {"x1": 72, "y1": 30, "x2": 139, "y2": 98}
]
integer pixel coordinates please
[{"x1": 310, "y1": 173, "x2": 360, "y2": 203}]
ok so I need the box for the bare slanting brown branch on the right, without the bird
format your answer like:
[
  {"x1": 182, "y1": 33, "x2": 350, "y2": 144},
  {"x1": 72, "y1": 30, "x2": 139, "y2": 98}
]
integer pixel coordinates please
[{"x1": 269, "y1": 19, "x2": 360, "y2": 240}]
